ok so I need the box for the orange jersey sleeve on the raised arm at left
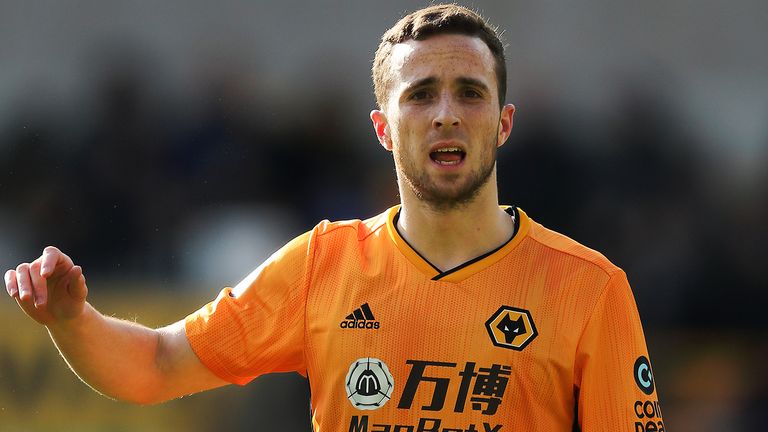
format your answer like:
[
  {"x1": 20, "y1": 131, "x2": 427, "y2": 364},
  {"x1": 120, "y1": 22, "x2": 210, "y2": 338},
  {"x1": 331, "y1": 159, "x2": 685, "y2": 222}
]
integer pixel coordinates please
[{"x1": 185, "y1": 232, "x2": 313, "y2": 385}]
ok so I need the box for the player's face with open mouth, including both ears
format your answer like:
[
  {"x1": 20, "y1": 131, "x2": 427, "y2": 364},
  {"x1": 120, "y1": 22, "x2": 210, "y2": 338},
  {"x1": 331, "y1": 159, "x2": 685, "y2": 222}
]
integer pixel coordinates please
[{"x1": 371, "y1": 35, "x2": 514, "y2": 209}]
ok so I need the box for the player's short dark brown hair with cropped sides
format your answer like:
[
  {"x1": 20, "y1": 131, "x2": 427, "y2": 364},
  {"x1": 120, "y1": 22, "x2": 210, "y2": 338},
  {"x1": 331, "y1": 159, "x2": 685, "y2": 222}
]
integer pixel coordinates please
[{"x1": 371, "y1": 4, "x2": 507, "y2": 109}]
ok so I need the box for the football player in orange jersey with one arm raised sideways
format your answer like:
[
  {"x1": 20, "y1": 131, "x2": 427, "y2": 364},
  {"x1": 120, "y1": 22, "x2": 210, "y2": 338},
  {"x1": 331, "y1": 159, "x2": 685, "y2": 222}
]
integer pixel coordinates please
[{"x1": 5, "y1": 4, "x2": 664, "y2": 432}]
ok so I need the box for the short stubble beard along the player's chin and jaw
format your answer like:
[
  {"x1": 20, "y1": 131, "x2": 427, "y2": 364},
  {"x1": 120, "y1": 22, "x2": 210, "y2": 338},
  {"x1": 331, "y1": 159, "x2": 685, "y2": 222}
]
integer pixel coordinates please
[{"x1": 395, "y1": 138, "x2": 496, "y2": 212}]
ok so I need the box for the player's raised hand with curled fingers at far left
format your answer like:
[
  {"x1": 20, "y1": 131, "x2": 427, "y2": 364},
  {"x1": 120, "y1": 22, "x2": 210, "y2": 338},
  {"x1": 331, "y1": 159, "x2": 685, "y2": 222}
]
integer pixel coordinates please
[{"x1": 5, "y1": 246, "x2": 88, "y2": 325}]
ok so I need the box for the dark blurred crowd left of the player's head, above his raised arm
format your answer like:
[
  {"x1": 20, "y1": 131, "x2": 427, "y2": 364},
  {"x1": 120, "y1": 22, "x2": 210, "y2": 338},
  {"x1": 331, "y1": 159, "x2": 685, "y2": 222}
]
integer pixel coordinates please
[{"x1": 0, "y1": 59, "x2": 388, "y2": 283}]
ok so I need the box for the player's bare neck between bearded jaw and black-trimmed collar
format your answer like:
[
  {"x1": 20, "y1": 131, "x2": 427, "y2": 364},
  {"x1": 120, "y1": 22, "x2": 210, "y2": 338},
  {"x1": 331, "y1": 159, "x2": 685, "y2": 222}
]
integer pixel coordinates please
[{"x1": 397, "y1": 175, "x2": 514, "y2": 271}]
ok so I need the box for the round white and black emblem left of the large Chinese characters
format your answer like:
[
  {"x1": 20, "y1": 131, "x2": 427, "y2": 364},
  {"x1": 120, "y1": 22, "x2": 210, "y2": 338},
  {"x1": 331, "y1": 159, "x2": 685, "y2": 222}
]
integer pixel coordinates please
[{"x1": 344, "y1": 357, "x2": 395, "y2": 410}]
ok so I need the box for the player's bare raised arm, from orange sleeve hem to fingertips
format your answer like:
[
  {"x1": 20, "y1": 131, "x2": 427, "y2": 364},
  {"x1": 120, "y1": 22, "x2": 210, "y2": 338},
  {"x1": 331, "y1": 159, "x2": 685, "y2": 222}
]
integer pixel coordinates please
[{"x1": 5, "y1": 247, "x2": 227, "y2": 404}]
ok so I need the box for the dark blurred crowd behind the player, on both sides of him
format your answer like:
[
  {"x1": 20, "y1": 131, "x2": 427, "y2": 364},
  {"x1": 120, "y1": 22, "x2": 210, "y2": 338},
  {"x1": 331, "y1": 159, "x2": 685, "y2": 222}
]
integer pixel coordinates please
[{"x1": 0, "y1": 43, "x2": 768, "y2": 430}]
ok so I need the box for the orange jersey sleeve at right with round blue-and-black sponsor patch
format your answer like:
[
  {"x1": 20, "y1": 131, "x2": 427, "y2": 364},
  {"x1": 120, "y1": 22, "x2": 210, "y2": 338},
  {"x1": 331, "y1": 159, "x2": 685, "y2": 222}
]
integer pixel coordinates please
[{"x1": 575, "y1": 271, "x2": 665, "y2": 432}]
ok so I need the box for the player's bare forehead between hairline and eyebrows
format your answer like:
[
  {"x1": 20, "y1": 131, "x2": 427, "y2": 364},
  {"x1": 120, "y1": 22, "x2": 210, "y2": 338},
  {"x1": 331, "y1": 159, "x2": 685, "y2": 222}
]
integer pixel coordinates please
[{"x1": 390, "y1": 34, "x2": 495, "y2": 88}]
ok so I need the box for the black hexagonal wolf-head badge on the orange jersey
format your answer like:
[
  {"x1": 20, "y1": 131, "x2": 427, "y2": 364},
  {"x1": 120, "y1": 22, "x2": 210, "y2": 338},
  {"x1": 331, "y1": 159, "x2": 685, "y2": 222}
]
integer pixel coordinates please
[{"x1": 485, "y1": 306, "x2": 539, "y2": 351}]
